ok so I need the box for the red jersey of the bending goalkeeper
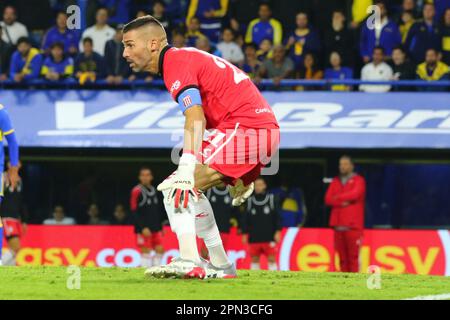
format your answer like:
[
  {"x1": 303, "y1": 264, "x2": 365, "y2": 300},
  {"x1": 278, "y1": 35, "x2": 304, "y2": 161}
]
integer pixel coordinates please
[{"x1": 159, "y1": 47, "x2": 279, "y2": 129}]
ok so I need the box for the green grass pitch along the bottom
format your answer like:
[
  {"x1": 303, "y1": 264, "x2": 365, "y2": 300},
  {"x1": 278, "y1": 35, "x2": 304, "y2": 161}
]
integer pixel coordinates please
[{"x1": 0, "y1": 267, "x2": 450, "y2": 300}]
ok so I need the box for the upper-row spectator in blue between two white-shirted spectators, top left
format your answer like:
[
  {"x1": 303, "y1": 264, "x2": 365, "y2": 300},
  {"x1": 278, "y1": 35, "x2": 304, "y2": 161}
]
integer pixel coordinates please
[{"x1": 42, "y1": 11, "x2": 79, "y2": 56}]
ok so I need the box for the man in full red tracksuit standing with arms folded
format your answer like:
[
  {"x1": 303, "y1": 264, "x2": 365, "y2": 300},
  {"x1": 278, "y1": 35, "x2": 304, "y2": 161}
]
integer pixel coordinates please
[{"x1": 325, "y1": 156, "x2": 366, "y2": 272}]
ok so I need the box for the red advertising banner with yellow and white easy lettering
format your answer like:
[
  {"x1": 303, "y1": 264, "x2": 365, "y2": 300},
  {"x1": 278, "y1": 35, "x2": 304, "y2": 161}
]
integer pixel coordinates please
[{"x1": 3, "y1": 225, "x2": 450, "y2": 276}]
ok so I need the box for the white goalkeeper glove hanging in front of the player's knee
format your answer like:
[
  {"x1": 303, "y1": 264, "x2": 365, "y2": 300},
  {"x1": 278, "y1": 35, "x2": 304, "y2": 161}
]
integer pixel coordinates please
[{"x1": 157, "y1": 153, "x2": 198, "y2": 209}]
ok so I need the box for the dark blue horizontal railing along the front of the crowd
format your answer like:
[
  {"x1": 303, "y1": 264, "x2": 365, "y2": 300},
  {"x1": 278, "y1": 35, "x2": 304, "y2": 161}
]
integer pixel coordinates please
[{"x1": 0, "y1": 79, "x2": 450, "y2": 91}]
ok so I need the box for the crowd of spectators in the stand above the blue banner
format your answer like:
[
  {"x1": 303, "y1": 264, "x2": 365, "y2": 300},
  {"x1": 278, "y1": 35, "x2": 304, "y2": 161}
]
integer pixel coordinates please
[{"x1": 0, "y1": 0, "x2": 450, "y2": 92}]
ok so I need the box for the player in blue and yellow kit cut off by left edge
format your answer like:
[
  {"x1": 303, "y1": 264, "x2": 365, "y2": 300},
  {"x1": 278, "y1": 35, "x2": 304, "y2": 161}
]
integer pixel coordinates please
[{"x1": 0, "y1": 104, "x2": 20, "y2": 265}]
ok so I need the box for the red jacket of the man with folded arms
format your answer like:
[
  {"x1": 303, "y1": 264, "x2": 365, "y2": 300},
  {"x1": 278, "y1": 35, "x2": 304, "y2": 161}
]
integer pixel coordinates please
[{"x1": 325, "y1": 174, "x2": 366, "y2": 230}]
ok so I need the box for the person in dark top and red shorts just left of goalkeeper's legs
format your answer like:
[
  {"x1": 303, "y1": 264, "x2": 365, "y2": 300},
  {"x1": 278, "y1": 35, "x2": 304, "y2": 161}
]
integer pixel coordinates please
[{"x1": 130, "y1": 167, "x2": 165, "y2": 267}]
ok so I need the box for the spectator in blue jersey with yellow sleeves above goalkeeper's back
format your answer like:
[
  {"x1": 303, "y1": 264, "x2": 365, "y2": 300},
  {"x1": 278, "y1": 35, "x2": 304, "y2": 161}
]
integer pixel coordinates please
[{"x1": 245, "y1": 3, "x2": 283, "y2": 46}]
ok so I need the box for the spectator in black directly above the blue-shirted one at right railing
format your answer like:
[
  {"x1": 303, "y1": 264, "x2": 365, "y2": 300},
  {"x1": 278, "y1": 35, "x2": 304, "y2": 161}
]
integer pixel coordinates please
[{"x1": 323, "y1": 10, "x2": 354, "y2": 66}]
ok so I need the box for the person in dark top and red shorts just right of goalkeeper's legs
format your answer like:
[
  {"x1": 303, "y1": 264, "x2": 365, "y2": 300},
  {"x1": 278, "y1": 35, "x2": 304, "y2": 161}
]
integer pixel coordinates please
[{"x1": 242, "y1": 177, "x2": 281, "y2": 270}]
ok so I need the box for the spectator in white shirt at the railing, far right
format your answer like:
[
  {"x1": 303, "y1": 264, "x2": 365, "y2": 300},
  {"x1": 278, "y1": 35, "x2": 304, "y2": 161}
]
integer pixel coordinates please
[{"x1": 359, "y1": 47, "x2": 393, "y2": 92}]
